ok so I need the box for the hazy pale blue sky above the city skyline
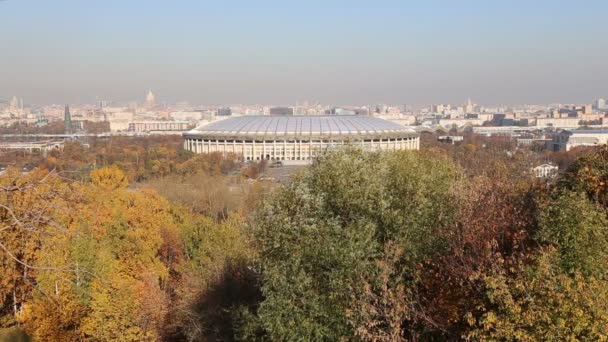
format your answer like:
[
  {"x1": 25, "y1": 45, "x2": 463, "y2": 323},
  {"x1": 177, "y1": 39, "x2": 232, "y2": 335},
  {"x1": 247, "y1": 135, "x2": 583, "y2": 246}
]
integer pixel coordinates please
[{"x1": 0, "y1": 0, "x2": 608, "y2": 105}]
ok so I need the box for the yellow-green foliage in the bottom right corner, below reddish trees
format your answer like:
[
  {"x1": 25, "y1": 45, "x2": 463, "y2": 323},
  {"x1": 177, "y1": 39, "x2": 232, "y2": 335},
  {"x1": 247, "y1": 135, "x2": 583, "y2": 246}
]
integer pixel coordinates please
[{"x1": 466, "y1": 249, "x2": 608, "y2": 341}]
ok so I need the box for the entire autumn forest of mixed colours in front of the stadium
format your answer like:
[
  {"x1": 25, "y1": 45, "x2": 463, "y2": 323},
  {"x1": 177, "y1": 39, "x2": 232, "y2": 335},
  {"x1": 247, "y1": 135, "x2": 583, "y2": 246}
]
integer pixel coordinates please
[{"x1": 0, "y1": 136, "x2": 608, "y2": 341}]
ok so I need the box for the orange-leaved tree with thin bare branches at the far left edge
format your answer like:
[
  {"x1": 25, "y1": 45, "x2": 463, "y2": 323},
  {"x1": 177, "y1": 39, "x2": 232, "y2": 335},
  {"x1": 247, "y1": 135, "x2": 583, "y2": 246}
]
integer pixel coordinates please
[{"x1": 0, "y1": 169, "x2": 67, "y2": 325}]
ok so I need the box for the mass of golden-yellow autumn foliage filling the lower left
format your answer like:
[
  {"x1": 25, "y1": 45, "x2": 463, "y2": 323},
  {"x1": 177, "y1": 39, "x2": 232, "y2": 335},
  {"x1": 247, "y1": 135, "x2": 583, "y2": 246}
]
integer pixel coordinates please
[{"x1": 0, "y1": 167, "x2": 257, "y2": 341}]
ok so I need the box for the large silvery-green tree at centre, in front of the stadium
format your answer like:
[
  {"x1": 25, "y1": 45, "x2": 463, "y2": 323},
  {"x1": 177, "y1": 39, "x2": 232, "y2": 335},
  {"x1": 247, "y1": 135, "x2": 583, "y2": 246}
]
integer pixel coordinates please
[{"x1": 252, "y1": 149, "x2": 460, "y2": 340}]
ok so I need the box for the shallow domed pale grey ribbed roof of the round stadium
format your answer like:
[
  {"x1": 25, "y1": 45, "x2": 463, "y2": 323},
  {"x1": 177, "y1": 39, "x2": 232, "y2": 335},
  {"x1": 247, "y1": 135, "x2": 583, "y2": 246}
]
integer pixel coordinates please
[{"x1": 187, "y1": 115, "x2": 414, "y2": 137}]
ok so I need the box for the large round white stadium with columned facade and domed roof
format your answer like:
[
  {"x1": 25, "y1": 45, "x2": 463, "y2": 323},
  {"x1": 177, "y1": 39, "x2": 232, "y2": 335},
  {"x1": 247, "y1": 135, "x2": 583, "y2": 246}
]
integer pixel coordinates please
[{"x1": 184, "y1": 115, "x2": 420, "y2": 163}]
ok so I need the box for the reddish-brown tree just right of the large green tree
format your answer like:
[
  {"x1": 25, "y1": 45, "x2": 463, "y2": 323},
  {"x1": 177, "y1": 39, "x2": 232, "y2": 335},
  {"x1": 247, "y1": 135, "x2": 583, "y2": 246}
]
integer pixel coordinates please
[{"x1": 417, "y1": 176, "x2": 542, "y2": 339}]
